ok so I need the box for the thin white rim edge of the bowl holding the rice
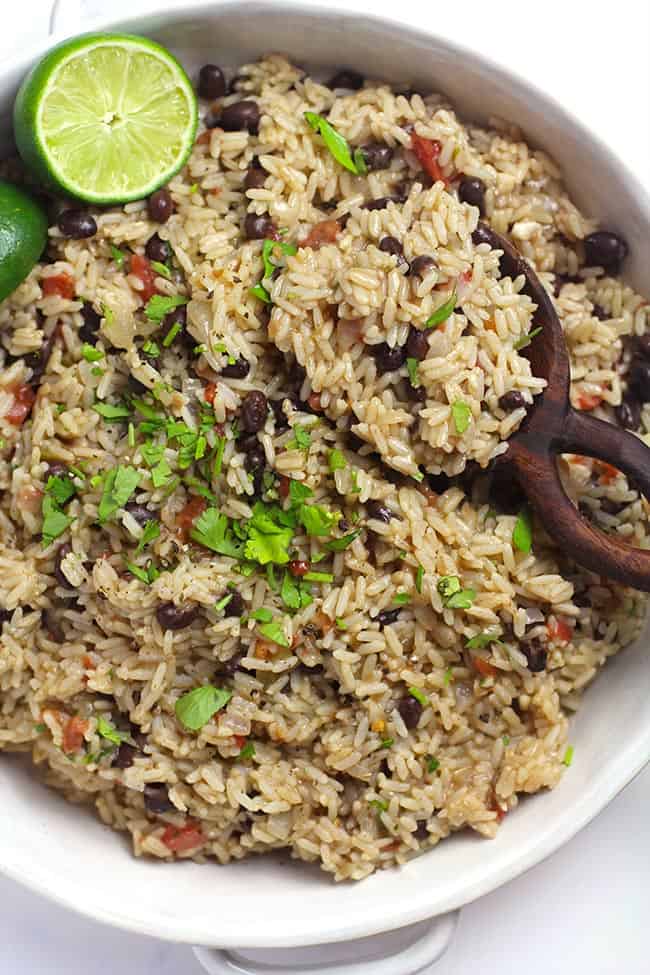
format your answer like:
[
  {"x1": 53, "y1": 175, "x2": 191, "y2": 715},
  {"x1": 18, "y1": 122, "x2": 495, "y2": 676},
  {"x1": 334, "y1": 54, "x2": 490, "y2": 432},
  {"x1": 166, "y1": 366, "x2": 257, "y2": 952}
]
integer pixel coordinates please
[{"x1": 0, "y1": 0, "x2": 650, "y2": 948}]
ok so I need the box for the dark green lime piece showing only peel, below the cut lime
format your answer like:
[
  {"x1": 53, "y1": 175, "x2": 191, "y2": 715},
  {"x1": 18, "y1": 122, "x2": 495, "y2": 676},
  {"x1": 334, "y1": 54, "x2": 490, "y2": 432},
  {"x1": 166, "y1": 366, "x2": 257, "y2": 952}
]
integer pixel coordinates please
[{"x1": 0, "y1": 181, "x2": 47, "y2": 301}]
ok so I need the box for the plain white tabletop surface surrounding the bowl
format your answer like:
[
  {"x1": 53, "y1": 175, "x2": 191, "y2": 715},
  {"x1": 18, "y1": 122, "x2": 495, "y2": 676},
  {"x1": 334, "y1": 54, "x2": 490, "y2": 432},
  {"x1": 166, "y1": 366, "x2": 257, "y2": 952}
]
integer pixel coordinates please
[{"x1": 0, "y1": 0, "x2": 650, "y2": 975}]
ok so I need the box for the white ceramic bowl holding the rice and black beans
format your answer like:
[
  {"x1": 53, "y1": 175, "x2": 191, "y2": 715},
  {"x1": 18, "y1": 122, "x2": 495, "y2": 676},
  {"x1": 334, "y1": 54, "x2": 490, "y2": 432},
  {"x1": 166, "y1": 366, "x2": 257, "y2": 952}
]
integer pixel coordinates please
[{"x1": 0, "y1": 0, "x2": 650, "y2": 975}]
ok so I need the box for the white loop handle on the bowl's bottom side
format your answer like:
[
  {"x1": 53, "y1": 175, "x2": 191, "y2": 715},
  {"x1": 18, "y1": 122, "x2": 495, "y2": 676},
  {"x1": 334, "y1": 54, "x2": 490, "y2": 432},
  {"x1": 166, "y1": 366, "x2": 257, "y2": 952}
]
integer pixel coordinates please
[{"x1": 194, "y1": 911, "x2": 460, "y2": 975}]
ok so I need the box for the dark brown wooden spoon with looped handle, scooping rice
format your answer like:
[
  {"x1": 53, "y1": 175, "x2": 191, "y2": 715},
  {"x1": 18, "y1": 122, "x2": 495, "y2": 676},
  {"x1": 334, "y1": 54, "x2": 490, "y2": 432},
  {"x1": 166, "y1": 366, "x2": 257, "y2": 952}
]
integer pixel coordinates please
[{"x1": 474, "y1": 224, "x2": 650, "y2": 592}]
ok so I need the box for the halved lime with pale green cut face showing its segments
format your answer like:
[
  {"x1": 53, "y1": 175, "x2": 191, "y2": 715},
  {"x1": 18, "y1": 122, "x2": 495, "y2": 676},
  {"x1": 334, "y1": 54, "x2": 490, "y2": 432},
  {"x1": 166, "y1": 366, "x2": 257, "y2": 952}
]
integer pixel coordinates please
[{"x1": 14, "y1": 34, "x2": 198, "y2": 203}]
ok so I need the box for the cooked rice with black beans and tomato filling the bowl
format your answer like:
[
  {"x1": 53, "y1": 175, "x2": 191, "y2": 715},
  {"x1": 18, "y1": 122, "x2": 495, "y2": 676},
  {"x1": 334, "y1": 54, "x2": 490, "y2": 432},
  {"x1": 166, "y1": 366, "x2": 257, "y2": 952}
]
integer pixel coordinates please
[{"x1": 0, "y1": 56, "x2": 650, "y2": 880}]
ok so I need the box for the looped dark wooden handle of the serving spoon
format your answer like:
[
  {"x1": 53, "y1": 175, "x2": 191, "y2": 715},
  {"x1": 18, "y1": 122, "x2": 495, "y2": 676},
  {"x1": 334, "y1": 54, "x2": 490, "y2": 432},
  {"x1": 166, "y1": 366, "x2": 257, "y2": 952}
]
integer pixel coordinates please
[{"x1": 508, "y1": 409, "x2": 650, "y2": 592}]
